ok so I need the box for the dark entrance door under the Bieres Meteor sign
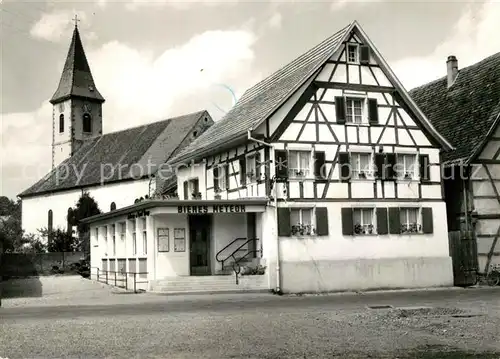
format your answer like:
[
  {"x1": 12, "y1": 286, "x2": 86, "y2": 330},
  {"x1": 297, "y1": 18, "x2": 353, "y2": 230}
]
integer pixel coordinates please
[{"x1": 189, "y1": 215, "x2": 211, "y2": 275}]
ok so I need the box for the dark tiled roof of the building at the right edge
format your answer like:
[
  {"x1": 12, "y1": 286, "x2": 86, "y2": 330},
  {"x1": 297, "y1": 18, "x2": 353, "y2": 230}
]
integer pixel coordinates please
[{"x1": 410, "y1": 52, "x2": 500, "y2": 164}]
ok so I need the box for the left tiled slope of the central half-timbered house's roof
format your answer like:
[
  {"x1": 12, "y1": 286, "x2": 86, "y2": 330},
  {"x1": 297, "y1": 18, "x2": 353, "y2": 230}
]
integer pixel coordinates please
[{"x1": 173, "y1": 24, "x2": 352, "y2": 161}]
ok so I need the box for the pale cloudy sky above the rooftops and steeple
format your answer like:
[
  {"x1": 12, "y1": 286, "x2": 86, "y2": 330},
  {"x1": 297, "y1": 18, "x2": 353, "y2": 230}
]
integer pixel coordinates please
[{"x1": 0, "y1": 0, "x2": 500, "y2": 198}]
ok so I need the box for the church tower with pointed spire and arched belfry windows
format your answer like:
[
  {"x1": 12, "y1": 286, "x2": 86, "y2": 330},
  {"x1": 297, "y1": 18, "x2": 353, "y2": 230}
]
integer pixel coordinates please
[{"x1": 50, "y1": 25, "x2": 105, "y2": 168}]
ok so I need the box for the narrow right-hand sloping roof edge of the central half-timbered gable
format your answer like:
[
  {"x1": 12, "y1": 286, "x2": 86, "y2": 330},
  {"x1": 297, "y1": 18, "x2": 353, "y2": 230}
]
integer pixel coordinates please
[{"x1": 354, "y1": 21, "x2": 455, "y2": 151}]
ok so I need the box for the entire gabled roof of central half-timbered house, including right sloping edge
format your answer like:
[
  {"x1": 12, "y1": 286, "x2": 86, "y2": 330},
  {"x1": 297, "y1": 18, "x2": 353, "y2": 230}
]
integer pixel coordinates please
[{"x1": 171, "y1": 21, "x2": 452, "y2": 163}]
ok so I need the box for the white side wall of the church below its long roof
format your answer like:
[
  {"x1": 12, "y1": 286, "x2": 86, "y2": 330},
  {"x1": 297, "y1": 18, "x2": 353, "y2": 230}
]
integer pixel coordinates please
[{"x1": 22, "y1": 179, "x2": 149, "y2": 239}]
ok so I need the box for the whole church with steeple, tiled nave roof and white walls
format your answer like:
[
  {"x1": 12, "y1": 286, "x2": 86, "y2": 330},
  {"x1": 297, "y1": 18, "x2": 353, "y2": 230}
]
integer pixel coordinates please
[{"x1": 18, "y1": 26, "x2": 214, "y2": 239}]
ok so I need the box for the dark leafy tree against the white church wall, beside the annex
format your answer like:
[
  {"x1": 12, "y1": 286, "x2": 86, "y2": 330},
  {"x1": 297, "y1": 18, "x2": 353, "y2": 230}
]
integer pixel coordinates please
[{"x1": 68, "y1": 192, "x2": 102, "y2": 253}]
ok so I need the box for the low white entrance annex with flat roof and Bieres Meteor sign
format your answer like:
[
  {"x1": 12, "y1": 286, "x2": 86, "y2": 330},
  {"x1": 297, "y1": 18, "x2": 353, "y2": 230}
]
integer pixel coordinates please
[{"x1": 87, "y1": 198, "x2": 274, "y2": 292}]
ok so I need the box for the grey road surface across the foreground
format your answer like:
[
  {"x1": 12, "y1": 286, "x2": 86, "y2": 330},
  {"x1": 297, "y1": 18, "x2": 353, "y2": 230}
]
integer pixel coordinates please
[{"x1": 0, "y1": 288, "x2": 500, "y2": 359}]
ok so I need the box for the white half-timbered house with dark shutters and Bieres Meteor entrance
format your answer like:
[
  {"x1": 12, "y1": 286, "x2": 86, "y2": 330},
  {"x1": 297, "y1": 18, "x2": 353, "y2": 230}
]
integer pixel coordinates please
[{"x1": 89, "y1": 22, "x2": 453, "y2": 292}]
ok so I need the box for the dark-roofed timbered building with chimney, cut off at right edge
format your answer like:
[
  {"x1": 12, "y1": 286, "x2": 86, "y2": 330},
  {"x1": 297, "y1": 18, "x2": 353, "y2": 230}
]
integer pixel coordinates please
[{"x1": 410, "y1": 53, "x2": 500, "y2": 284}]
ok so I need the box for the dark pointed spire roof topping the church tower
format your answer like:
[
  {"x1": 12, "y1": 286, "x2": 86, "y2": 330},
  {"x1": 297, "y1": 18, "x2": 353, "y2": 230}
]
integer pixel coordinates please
[{"x1": 50, "y1": 27, "x2": 104, "y2": 104}]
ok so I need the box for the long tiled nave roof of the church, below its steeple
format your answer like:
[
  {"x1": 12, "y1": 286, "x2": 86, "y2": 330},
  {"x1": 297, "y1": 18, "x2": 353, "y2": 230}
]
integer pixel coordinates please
[{"x1": 19, "y1": 111, "x2": 212, "y2": 197}]
